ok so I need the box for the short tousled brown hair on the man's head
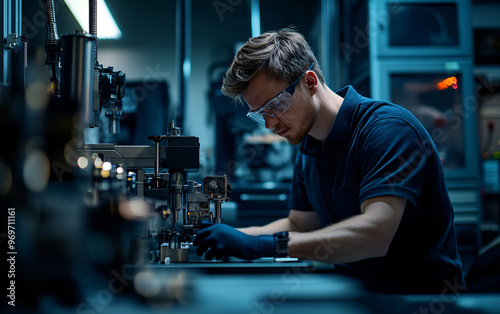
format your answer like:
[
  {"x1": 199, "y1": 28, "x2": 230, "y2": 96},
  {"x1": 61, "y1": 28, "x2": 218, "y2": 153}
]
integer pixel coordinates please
[{"x1": 221, "y1": 28, "x2": 325, "y2": 101}]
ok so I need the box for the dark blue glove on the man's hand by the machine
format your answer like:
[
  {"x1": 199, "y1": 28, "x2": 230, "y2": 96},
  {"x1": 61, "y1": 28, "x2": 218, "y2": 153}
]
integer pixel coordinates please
[{"x1": 193, "y1": 224, "x2": 276, "y2": 260}]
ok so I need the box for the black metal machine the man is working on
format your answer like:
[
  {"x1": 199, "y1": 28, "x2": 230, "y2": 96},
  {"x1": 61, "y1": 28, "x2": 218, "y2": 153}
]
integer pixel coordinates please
[{"x1": 41, "y1": 0, "x2": 230, "y2": 264}]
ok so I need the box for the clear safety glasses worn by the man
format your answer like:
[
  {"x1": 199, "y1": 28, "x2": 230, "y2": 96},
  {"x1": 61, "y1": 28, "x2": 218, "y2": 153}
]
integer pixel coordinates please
[{"x1": 247, "y1": 63, "x2": 314, "y2": 124}]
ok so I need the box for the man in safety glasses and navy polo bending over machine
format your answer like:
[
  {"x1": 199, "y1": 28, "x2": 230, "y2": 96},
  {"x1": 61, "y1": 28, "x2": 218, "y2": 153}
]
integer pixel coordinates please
[{"x1": 194, "y1": 29, "x2": 463, "y2": 293}]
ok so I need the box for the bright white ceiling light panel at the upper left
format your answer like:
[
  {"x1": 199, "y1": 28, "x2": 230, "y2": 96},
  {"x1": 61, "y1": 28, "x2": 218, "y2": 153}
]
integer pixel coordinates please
[{"x1": 64, "y1": 0, "x2": 122, "y2": 39}]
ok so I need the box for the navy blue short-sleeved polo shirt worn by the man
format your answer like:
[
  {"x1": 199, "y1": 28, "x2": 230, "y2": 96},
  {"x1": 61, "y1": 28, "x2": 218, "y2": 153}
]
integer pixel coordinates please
[{"x1": 289, "y1": 86, "x2": 463, "y2": 293}]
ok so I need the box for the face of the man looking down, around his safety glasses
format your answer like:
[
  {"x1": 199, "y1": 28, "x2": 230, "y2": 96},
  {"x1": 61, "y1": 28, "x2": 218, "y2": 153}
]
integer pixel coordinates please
[{"x1": 241, "y1": 73, "x2": 317, "y2": 145}]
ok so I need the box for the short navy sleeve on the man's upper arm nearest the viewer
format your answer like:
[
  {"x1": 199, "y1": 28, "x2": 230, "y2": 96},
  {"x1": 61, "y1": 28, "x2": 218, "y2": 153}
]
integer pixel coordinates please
[{"x1": 357, "y1": 117, "x2": 433, "y2": 207}]
